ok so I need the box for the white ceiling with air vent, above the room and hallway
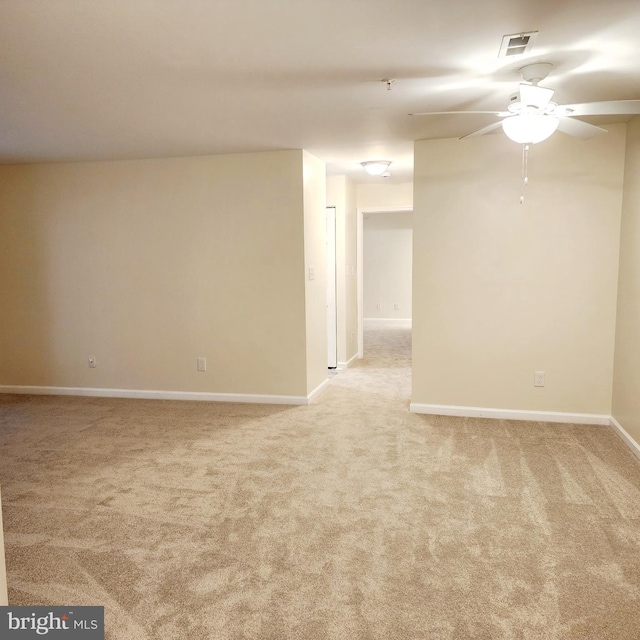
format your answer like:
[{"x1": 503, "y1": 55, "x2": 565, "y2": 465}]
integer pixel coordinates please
[{"x1": 0, "y1": 0, "x2": 640, "y2": 181}]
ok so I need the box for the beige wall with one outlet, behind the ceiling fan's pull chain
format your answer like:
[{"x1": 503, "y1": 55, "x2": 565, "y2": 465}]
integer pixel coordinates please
[{"x1": 412, "y1": 125, "x2": 625, "y2": 415}]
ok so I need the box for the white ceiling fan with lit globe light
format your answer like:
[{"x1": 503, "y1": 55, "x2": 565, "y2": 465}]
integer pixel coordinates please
[{"x1": 410, "y1": 62, "x2": 640, "y2": 144}]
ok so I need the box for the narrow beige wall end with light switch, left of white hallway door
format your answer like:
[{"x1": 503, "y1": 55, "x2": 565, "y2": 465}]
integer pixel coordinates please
[{"x1": 303, "y1": 151, "x2": 328, "y2": 395}]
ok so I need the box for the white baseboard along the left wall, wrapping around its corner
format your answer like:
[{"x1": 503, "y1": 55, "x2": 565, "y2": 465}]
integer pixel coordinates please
[{"x1": 0, "y1": 381, "x2": 310, "y2": 405}]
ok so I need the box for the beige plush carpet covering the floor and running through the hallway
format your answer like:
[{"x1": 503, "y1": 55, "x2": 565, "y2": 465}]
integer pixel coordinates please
[{"x1": 0, "y1": 327, "x2": 640, "y2": 640}]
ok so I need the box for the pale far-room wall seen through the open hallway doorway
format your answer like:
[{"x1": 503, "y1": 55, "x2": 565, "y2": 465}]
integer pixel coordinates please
[{"x1": 363, "y1": 211, "x2": 413, "y2": 318}]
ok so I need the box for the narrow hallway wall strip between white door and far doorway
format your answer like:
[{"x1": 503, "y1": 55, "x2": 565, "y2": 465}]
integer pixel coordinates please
[{"x1": 327, "y1": 176, "x2": 358, "y2": 366}]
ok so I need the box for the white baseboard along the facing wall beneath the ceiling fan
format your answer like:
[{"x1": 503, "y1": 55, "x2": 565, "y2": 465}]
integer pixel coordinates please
[{"x1": 409, "y1": 402, "x2": 610, "y2": 426}]
